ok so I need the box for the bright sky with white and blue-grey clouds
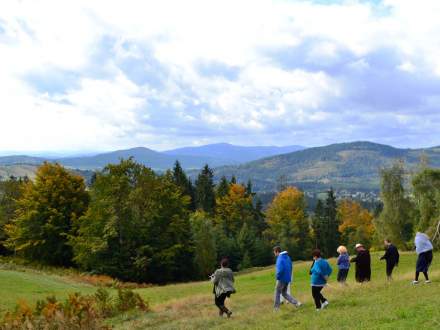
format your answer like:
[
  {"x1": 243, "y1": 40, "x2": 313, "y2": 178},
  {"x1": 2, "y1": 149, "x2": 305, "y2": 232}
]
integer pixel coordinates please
[{"x1": 0, "y1": 0, "x2": 440, "y2": 154}]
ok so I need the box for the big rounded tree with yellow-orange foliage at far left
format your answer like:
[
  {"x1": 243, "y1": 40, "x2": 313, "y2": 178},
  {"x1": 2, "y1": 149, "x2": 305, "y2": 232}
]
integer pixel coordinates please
[{"x1": 6, "y1": 163, "x2": 89, "y2": 265}]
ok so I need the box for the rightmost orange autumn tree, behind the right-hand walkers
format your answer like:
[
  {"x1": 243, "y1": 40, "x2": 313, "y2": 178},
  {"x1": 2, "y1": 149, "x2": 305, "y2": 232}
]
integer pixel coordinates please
[{"x1": 337, "y1": 200, "x2": 374, "y2": 248}]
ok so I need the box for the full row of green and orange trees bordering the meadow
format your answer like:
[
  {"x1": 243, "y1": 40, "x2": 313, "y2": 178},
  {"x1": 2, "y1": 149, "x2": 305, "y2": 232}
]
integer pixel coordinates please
[{"x1": 0, "y1": 159, "x2": 440, "y2": 283}]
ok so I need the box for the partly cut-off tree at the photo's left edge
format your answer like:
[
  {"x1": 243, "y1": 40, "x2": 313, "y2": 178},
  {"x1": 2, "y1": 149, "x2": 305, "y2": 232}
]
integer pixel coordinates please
[{"x1": 0, "y1": 176, "x2": 27, "y2": 254}]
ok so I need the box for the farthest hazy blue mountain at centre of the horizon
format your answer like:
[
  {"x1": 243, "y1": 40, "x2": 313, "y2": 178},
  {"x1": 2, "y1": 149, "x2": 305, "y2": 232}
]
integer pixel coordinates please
[{"x1": 164, "y1": 143, "x2": 305, "y2": 165}]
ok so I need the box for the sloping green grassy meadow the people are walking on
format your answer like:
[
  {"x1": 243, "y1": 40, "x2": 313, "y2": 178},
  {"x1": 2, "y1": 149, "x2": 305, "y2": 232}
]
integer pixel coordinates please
[{"x1": 0, "y1": 253, "x2": 440, "y2": 329}]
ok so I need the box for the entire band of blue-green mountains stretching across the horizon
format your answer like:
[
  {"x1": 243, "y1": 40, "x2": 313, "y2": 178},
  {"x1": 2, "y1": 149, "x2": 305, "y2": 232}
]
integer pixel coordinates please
[{"x1": 0, "y1": 142, "x2": 440, "y2": 192}]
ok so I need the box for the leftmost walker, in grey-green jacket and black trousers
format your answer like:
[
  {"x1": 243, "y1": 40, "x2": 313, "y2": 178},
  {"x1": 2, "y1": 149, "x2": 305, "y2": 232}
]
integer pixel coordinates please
[{"x1": 211, "y1": 258, "x2": 235, "y2": 318}]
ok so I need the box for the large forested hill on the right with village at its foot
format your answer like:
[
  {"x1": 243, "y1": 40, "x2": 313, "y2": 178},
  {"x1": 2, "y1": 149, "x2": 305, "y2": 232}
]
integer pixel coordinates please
[{"x1": 211, "y1": 142, "x2": 440, "y2": 191}]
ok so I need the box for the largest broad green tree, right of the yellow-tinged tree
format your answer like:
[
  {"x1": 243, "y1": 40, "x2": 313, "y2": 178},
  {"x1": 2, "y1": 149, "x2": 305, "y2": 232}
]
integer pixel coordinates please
[{"x1": 71, "y1": 159, "x2": 194, "y2": 283}]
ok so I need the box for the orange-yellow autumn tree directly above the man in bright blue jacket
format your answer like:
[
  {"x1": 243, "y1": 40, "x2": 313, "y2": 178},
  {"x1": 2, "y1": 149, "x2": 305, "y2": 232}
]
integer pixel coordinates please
[{"x1": 266, "y1": 187, "x2": 310, "y2": 258}]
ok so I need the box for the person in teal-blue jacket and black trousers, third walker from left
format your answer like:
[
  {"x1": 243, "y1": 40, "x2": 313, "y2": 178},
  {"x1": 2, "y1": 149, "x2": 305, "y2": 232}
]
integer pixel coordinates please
[{"x1": 310, "y1": 249, "x2": 332, "y2": 311}]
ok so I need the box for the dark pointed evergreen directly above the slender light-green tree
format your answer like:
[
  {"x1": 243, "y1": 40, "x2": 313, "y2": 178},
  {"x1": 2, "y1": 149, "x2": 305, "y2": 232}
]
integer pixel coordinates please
[{"x1": 195, "y1": 165, "x2": 215, "y2": 214}]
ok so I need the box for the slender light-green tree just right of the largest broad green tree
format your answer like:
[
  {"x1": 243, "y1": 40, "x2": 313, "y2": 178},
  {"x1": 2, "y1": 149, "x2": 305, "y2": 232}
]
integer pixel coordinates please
[{"x1": 191, "y1": 211, "x2": 217, "y2": 279}]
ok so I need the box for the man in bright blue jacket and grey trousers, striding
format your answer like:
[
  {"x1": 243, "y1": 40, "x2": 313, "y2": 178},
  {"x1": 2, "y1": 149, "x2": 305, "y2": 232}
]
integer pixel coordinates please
[{"x1": 273, "y1": 246, "x2": 301, "y2": 311}]
